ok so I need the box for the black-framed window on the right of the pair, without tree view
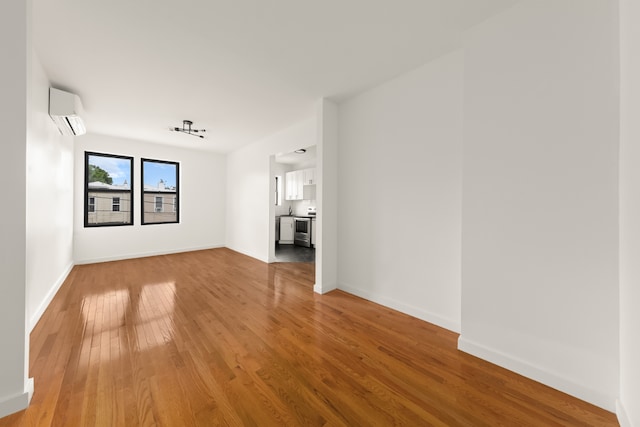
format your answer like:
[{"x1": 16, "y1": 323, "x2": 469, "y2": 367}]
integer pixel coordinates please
[{"x1": 141, "y1": 159, "x2": 180, "y2": 225}]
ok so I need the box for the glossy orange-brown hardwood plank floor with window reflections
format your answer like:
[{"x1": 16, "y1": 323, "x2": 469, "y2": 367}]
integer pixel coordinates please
[{"x1": 0, "y1": 249, "x2": 617, "y2": 426}]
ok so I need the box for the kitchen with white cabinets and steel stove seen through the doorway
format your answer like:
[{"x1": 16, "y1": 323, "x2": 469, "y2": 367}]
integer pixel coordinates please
[{"x1": 272, "y1": 146, "x2": 316, "y2": 262}]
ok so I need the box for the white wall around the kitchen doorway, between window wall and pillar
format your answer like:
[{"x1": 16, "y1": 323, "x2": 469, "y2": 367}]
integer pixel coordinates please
[{"x1": 226, "y1": 117, "x2": 316, "y2": 262}]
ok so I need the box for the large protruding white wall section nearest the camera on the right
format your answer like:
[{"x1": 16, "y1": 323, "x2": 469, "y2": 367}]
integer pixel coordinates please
[{"x1": 460, "y1": 0, "x2": 619, "y2": 410}]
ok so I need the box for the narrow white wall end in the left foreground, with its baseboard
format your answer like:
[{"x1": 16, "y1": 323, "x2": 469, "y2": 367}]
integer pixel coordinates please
[{"x1": 0, "y1": 0, "x2": 33, "y2": 417}]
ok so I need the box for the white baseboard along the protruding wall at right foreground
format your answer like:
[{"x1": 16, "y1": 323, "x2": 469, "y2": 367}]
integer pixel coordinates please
[{"x1": 458, "y1": 335, "x2": 615, "y2": 412}]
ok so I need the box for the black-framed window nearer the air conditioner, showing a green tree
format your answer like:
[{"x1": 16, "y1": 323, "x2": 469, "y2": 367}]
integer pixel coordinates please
[{"x1": 84, "y1": 151, "x2": 133, "y2": 227}]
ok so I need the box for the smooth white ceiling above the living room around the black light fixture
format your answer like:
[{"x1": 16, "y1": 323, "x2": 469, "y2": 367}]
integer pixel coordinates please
[{"x1": 33, "y1": 0, "x2": 515, "y2": 152}]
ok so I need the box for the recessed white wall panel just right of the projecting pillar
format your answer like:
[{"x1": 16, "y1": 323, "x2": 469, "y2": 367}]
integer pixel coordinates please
[{"x1": 338, "y1": 51, "x2": 463, "y2": 331}]
